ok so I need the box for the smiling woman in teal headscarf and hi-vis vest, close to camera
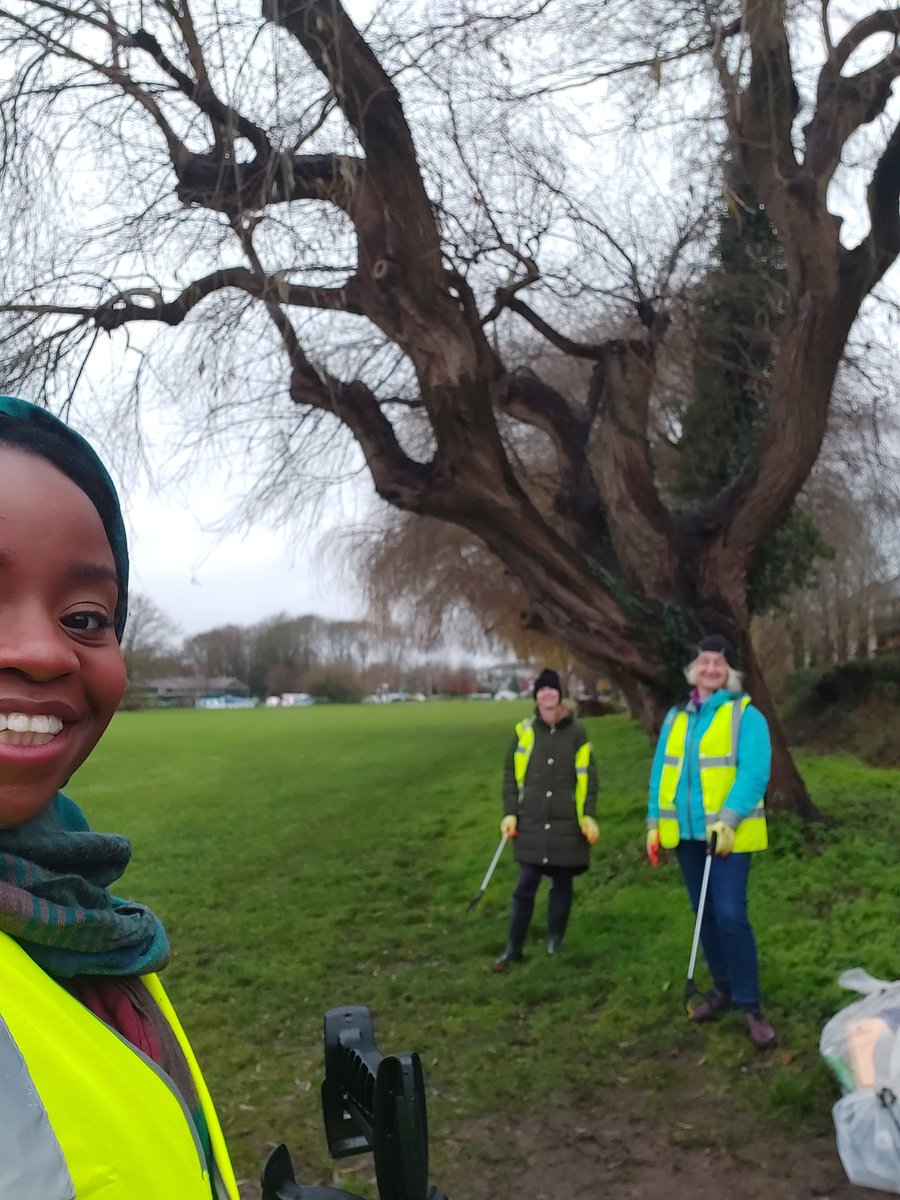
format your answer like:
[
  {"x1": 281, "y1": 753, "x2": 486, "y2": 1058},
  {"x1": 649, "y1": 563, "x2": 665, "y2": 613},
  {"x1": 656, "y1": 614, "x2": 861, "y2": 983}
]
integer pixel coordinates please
[{"x1": 0, "y1": 397, "x2": 238, "y2": 1200}]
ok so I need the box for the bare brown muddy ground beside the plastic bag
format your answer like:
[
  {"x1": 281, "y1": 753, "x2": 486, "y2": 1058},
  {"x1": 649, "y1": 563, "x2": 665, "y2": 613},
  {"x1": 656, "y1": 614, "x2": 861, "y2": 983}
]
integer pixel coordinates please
[{"x1": 234, "y1": 1063, "x2": 896, "y2": 1200}]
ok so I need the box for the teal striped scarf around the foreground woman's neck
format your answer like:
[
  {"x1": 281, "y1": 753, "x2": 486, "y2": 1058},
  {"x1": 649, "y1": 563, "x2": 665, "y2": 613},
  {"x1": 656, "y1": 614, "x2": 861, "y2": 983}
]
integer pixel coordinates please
[{"x1": 0, "y1": 792, "x2": 169, "y2": 978}]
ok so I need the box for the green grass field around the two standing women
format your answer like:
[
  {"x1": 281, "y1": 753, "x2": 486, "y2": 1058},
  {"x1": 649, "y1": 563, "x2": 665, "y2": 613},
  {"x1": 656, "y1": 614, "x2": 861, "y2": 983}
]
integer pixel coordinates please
[{"x1": 68, "y1": 703, "x2": 900, "y2": 1189}]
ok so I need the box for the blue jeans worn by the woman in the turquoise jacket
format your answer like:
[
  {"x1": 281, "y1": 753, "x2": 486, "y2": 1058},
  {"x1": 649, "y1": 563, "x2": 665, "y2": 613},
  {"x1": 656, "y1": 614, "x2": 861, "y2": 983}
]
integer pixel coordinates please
[{"x1": 676, "y1": 841, "x2": 760, "y2": 1008}]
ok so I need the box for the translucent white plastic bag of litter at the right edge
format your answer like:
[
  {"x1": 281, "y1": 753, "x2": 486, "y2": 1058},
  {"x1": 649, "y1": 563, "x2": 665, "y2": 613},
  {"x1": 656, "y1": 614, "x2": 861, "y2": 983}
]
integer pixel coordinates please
[{"x1": 818, "y1": 968, "x2": 900, "y2": 1193}]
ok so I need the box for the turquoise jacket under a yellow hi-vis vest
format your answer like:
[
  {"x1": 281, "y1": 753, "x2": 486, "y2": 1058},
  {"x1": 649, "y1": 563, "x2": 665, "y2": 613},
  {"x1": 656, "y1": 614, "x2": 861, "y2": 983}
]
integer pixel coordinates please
[{"x1": 647, "y1": 688, "x2": 772, "y2": 841}]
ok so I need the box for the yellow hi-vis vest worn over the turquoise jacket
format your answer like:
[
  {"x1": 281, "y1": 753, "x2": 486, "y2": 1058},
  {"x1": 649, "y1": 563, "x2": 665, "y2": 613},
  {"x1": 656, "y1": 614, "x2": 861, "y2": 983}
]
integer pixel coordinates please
[{"x1": 659, "y1": 696, "x2": 769, "y2": 853}]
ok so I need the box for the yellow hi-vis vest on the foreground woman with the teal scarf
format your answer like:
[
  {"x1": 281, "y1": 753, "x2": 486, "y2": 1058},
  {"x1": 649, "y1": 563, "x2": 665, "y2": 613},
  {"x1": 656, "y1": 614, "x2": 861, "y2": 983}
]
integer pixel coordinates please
[{"x1": 0, "y1": 934, "x2": 239, "y2": 1200}]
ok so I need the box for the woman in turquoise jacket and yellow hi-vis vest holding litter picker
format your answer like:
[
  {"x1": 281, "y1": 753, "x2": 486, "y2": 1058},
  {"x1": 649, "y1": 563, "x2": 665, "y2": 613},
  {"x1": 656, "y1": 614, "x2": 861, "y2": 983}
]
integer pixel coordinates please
[{"x1": 647, "y1": 634, "x2": 775, "y2": 1049}]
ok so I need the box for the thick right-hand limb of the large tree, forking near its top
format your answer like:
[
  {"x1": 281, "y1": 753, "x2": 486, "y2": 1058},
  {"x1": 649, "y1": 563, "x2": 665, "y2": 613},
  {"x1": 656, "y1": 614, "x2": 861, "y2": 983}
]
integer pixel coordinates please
[{"x1": 710, "y1": 0, "x2": 900, "y2": 568}]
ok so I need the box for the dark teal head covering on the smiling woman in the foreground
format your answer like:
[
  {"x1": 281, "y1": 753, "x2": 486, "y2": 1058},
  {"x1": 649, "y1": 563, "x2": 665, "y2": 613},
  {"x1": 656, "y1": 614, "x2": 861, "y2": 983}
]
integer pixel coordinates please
[{"x1": 0, "y1": 396, "x2": 128, "y2": 642}]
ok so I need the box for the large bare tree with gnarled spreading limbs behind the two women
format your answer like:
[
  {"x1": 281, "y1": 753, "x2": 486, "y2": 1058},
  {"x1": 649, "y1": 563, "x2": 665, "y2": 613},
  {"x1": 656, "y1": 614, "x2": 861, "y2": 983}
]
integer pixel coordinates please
[{"x1": 0, "y1": 0, "x2": 900, "y2": 810}]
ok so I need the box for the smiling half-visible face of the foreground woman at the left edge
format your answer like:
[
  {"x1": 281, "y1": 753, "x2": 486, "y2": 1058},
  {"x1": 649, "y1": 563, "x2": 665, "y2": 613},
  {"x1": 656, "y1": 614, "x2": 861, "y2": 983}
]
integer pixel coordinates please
[{"x1": 0, "y1": 443, "x2": 126, "y2": 828}]
